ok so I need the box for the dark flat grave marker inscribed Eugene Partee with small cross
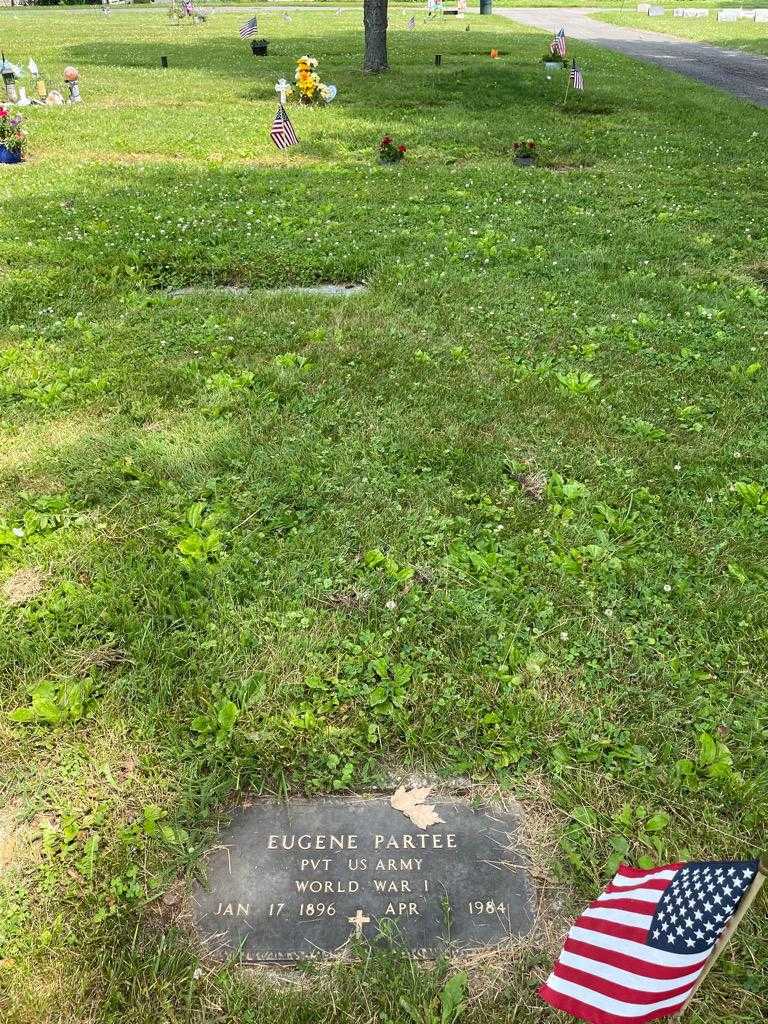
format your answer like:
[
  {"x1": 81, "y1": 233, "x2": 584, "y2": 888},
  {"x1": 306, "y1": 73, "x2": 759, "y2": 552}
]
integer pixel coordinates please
[{"x1": 193, "y1": 791, "x2": 535, "y2": 964}]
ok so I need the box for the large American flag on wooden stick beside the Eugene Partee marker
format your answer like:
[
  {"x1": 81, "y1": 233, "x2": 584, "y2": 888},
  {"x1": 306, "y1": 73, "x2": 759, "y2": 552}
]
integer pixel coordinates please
[{"x1": 539, "y1": 860, "x2": 760, "y2": 1024}]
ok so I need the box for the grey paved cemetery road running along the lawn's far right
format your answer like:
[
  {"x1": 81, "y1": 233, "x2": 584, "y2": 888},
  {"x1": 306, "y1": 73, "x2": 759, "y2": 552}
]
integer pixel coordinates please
[{"x1": 494, "y1": 7, "x2": 768, "y2": 108}]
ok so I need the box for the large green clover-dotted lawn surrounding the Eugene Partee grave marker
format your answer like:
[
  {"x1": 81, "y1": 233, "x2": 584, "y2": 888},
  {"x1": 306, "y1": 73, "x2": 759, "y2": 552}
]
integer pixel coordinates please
[{"x1": 0, "y1": 11, "x2": 768, "y2": 1024}]
